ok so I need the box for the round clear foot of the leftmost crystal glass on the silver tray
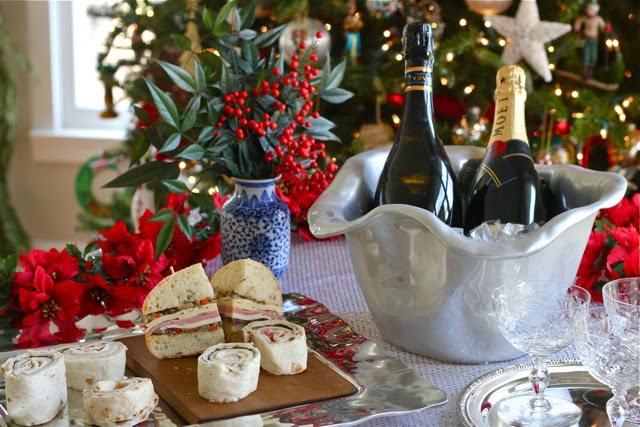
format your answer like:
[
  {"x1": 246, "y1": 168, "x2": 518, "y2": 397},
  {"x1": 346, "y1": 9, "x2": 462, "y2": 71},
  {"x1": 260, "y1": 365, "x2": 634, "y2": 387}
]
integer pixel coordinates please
[{"x1": 488, "y1": 393, "x2": 582, "y2": 427}]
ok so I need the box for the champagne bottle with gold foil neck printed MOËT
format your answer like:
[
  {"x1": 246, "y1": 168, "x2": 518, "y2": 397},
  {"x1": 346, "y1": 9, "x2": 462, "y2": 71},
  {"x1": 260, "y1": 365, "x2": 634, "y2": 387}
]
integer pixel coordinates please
[{"x1": 464, "y1": 65, "x2": 545, "y2": 233}]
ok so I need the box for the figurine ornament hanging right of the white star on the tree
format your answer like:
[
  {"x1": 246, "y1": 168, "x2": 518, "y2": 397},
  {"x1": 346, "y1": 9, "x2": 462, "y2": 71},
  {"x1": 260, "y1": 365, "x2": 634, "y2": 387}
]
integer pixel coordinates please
[{"x1": 573, "y1": 0, "x2": 611, "y2": 80}]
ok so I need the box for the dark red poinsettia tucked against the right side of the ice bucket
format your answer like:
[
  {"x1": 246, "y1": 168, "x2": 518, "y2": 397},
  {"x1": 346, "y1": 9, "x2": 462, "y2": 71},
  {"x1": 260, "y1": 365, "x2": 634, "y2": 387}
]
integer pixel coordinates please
[{"x1": 576, "y1": 231, "x2": 607, "y2": 301}]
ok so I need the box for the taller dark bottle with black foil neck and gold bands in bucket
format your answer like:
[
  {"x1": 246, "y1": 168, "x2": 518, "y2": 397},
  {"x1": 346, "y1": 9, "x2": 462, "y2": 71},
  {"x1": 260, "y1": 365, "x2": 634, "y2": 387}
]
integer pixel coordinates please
[{"x1": 374, "y1": 22, "x2": 462, "y2": 227}]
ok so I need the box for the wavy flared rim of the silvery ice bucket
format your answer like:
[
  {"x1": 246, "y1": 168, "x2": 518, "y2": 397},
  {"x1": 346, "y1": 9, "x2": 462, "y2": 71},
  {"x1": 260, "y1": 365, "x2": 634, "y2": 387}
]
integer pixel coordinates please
[{"x1": 308, "y1": 146, "x2": 627, "y2": 259}]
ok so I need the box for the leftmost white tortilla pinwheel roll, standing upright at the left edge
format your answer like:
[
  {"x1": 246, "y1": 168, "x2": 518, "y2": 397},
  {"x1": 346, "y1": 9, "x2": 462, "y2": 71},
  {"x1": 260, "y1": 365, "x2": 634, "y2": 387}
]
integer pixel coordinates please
[{"x1": 0, "y1": 350, "x2": 67, "y2": 426}]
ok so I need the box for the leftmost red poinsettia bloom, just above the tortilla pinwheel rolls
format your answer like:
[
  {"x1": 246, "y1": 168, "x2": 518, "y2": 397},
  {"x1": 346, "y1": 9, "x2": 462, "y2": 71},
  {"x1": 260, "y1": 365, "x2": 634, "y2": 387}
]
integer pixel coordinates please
[{"x1": 17, "y1": 266, "x2": 83, "y2": 327}]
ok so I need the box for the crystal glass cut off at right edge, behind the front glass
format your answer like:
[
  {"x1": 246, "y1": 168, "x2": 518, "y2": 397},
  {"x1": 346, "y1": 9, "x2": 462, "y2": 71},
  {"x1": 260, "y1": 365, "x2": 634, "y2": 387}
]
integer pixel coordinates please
[{"x1": 602, "y1": 277, "x2": 640, "y2": 424}]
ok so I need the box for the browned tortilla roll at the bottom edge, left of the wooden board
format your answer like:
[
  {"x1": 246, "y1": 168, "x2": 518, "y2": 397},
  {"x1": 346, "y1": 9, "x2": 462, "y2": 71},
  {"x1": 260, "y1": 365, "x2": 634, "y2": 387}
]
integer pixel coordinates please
[{"x1": 83, "y1": 377, "x2": 158, "y2": 427}]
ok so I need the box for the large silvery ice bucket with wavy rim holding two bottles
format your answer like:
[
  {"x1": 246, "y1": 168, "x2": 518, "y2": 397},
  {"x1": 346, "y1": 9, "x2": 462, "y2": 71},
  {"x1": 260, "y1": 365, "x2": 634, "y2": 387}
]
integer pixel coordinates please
[{"x1": 309, "y1": 146, "x2": 626, "y2": 363}]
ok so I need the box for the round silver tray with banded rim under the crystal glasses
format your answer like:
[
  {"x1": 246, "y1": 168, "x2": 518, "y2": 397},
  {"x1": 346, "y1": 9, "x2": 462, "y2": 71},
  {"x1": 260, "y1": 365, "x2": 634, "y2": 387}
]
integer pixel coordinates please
[{"x1": 458, "y1": 359, "x2": 637, "y2": 427}]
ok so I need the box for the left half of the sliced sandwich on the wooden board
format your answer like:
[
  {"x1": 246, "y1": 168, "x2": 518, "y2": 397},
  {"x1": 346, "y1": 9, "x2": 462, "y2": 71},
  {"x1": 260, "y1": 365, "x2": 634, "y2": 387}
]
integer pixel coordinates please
[{"x1": 142, "y1": 264, "x2": 224, "y2": 359}]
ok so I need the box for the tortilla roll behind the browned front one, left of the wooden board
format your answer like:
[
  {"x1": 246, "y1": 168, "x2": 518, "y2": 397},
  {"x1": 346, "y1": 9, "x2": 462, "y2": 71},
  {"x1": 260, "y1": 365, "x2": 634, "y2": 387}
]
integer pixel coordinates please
[{"x1": 62, "y1": 341, "x2": 127, "y2": 390}]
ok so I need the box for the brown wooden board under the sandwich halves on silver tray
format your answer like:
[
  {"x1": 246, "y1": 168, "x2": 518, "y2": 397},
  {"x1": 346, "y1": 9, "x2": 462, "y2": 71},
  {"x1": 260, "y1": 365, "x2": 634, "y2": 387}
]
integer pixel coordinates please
[{"x1": 118, "y1": 336, "x2": 358, "y2": 424}]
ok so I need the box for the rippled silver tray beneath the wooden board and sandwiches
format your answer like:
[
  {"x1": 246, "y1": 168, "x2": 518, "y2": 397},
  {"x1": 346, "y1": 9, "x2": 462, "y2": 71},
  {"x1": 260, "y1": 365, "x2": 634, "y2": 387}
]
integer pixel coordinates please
[{"x1": 0, "y1": 294, "x2": 447, "y2": 427}]
